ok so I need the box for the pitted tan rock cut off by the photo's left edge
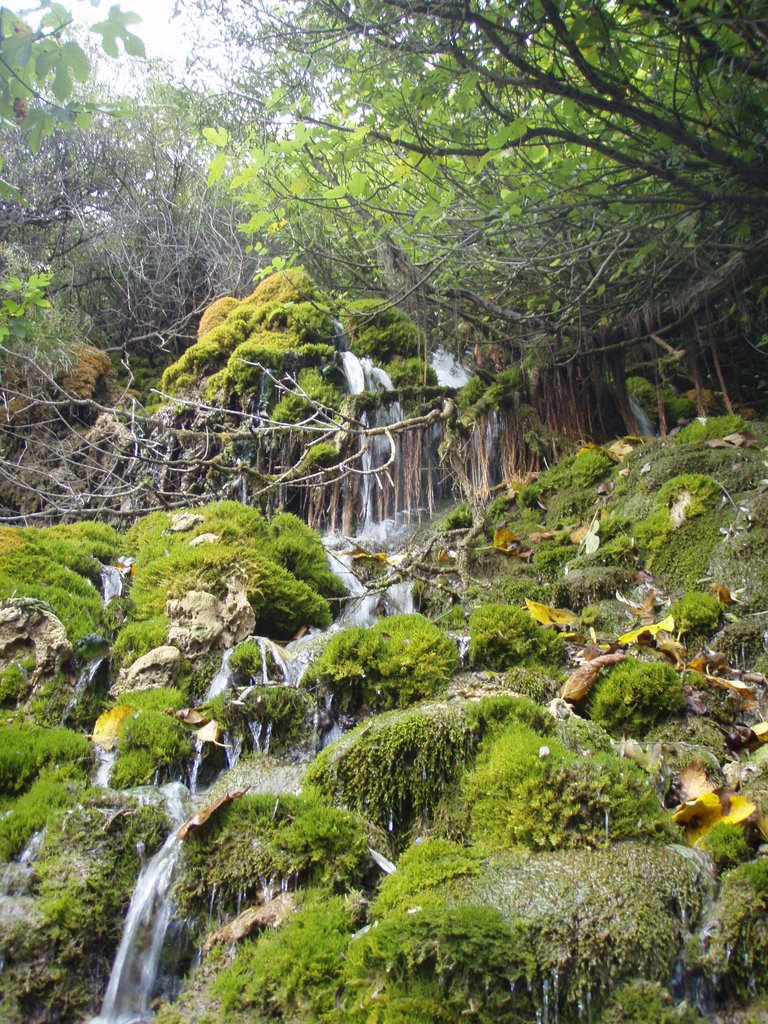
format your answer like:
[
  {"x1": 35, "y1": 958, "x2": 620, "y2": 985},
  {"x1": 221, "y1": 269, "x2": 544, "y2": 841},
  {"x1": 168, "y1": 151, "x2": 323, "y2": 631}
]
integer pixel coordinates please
[{"x1": 0, "y1": 597, "x2": 73, "y2": 684}]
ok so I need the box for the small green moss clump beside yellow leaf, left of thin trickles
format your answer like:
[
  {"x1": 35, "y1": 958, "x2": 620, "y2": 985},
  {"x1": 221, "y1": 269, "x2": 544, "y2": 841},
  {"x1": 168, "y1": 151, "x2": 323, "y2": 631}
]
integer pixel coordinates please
[{"x1": 111, "y1": 709, "x2": 193, "y2": 790}]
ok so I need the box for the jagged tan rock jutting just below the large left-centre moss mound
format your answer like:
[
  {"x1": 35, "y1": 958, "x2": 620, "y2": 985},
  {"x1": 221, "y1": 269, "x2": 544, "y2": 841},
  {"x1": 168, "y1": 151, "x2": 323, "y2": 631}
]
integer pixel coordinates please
[{"x1": 166, "y1": 577, "x2": 256, "y2": 658}]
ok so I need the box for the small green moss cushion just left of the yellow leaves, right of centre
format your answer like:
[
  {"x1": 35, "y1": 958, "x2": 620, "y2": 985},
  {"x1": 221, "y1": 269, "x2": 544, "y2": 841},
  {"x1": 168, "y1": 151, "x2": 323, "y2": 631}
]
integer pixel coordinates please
[{"x1": 469, "y1": 604, "x2": 564, "y2": 670}]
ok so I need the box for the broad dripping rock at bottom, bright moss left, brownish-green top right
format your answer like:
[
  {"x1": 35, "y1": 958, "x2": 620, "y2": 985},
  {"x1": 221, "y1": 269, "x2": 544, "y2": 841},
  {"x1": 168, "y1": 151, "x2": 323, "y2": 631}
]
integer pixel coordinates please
[{"x1": 329, "y1": 844, "x2": 701, "y2": 1024}]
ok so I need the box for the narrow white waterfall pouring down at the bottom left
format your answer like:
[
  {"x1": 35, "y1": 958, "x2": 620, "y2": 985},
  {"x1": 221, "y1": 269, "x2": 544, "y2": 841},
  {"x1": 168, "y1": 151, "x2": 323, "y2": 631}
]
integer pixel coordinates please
[{"x1": 90, "y1": 782, "x2": 187, "y2": 1024}]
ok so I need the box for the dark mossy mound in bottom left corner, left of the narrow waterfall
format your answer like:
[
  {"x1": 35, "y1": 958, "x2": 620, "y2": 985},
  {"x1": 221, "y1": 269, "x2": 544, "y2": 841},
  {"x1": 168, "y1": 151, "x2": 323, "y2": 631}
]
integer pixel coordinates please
[{"x1": 0, "y1": 792, "x2": 167, "y2": 1024}]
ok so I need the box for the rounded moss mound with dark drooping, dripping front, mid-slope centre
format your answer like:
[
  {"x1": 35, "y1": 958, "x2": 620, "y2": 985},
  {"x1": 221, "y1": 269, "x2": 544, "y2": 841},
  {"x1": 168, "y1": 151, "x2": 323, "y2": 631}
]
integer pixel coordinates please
[{"x1": 306, "y1": 696, "x2": 549, "y2": 835}]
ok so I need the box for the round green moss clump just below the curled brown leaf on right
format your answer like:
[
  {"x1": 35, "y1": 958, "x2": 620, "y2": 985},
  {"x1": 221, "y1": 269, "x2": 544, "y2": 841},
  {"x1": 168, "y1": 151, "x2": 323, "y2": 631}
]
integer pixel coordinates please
[{"x1": 588, "y1": 657, "x2": 684, "y2": 738}]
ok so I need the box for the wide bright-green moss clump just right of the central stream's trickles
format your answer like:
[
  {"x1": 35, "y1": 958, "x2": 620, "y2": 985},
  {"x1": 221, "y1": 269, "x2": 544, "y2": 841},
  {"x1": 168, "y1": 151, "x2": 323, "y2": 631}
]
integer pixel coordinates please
[{"x1": 302, "y1": 614, "x2": 459, "y2": 712}]
